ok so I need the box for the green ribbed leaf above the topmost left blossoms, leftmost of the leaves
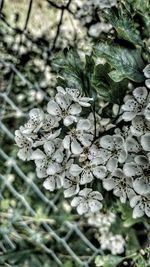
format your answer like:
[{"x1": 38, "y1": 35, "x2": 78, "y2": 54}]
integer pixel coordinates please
[{"x1": 52, "y1": 50, "x2": 84, "y2": 89}]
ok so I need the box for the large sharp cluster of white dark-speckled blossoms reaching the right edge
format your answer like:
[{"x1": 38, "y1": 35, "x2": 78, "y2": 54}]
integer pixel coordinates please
[{"x1": 15, "y1": 65, "x2": 150, "y2": 218}]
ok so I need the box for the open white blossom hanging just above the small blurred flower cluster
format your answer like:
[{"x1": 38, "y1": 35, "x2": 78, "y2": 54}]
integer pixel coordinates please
[{"x1": 71, "y1": 188, "x2": 103, "y2": 214}]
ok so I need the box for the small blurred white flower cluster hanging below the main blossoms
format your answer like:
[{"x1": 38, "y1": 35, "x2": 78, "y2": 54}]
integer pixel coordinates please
[{"x1": 88, "y1": 212, "x2": 125, "y2": 255}]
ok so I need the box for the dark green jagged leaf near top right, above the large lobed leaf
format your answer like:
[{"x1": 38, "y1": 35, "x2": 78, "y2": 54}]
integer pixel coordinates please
[{"x1": 105, "y1": 6, "x2": 143, "y2": 46}]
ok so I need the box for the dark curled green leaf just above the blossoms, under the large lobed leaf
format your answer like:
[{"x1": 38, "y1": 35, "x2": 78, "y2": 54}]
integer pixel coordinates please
[{"x1": 92, "y1": 63, "x2": 127, "y2": 104}]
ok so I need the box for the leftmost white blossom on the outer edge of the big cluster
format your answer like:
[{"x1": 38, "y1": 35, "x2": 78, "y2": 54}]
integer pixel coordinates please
[{"x1": 15, "y1": 130, "x2": 33, "y2": 161}]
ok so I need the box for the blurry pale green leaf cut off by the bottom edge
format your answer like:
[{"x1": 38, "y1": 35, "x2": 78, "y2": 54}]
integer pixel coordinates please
[{"x1": 95, "y1": 255, "x2": 125, "y2": 267}]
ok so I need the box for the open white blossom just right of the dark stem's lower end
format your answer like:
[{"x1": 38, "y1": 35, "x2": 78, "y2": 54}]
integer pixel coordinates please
[{"x1": 100, "y1": 135, "x2": 127, "y2": 171}]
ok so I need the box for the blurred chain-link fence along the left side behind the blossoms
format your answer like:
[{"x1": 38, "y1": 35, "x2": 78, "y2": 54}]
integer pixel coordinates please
[{"x1": 0, "y1": 0, "x2": 101, "y2": 267}]
